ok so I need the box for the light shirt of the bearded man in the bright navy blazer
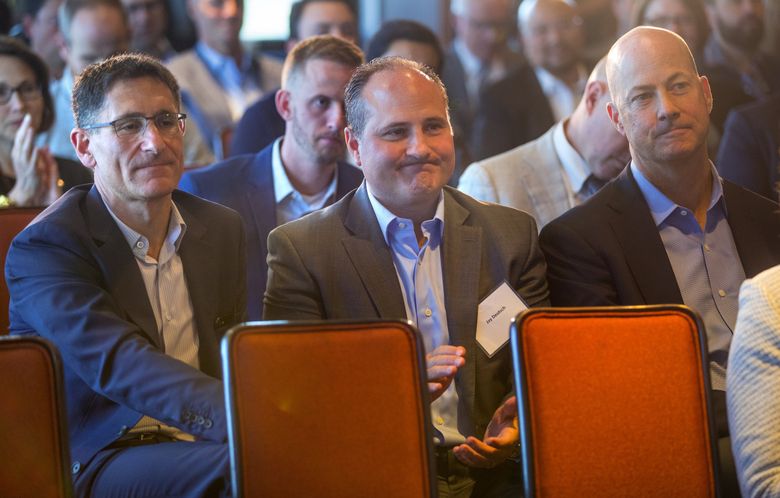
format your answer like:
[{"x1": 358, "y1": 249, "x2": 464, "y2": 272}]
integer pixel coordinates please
[{"x1": 271, "y1": 138, "x2": 338, "y2": 225}]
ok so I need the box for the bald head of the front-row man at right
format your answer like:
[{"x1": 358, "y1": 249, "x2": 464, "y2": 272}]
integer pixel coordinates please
[{"x1": 606, "y1": 27, "x2": 712, "y2": 171}]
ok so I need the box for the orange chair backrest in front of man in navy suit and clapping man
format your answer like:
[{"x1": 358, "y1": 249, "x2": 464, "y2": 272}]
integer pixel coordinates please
[{"x1": 222, "y1": 321, "x2": 436, "y2": 498}]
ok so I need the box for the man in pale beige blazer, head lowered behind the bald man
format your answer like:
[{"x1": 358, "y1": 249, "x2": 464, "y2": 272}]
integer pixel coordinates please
[{"x1": 458, "y1": 59, "x2": 631, "y2": 229}]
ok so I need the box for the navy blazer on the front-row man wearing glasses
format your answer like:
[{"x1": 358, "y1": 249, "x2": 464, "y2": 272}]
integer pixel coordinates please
[{"x1": 6, "y1": 185, "x2": 246, "y2": 477}]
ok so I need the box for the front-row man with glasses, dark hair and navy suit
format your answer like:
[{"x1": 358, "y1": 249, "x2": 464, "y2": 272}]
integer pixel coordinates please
[{"x1": 6, "y1": 51, "x2": 246, "y2": 497}]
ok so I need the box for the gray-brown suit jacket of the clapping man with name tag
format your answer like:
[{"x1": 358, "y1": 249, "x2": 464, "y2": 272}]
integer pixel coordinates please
[{"x1": 264, "y1": 183, "x2": 548, "y2": 438}]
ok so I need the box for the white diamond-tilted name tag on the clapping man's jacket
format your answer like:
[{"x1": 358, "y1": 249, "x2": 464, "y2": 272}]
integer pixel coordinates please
[{"x1": 477, "y1": 282, "x2": 528, "y2": 357}]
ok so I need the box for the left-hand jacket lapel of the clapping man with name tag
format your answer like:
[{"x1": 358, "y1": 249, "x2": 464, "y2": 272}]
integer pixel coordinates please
[{"x1": 342, "y1": 183, "x2": 406, "y2": 319}]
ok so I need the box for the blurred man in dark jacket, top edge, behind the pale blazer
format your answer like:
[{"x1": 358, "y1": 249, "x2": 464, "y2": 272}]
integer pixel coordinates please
[{"x1": 441, "y1": 0, "x2": 555, "y2": 162}]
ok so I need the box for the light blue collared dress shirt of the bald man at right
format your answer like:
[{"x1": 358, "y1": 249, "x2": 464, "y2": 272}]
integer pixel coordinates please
[{"x1": 631, "y1": 161, "x2": 745, "y2": 391}]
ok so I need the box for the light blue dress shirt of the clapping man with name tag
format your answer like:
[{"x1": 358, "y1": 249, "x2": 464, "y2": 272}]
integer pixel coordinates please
[{"x1": 367, "y1": 185, "x2": 466, "y2": 446}]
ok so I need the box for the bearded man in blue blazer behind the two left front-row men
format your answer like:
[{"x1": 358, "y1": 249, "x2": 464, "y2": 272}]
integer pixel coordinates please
[{"x1": 181, "y1": 35, "x2": 363, "y2": 320}]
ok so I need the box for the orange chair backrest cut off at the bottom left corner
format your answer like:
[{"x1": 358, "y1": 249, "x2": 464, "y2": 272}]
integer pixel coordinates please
[{"x1": 0, "y1": 336, "x2": 72, "y2": 498}]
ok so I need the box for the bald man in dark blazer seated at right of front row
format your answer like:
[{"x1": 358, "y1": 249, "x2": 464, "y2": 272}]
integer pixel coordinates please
[{"x1": 541, "y1": 27, "x2": 780, "y2": 496}]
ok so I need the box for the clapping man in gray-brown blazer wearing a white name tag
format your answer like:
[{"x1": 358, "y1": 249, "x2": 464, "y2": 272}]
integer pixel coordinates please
[{"x1": 264, "y1": 58, "x2": 548, "y2": 496}]
